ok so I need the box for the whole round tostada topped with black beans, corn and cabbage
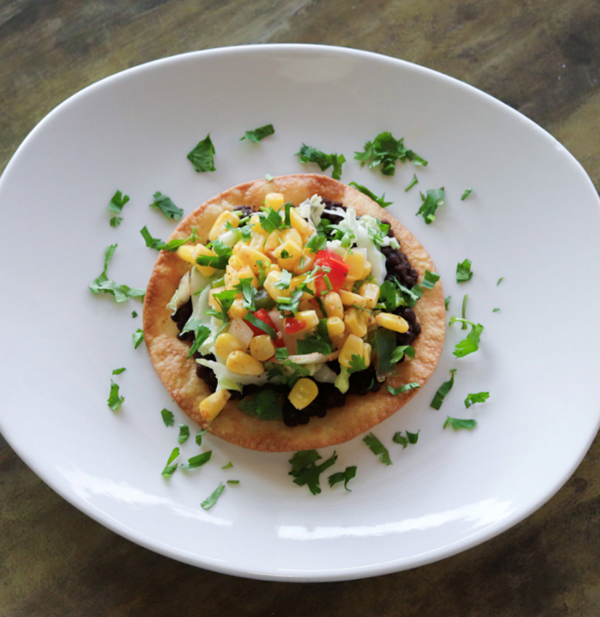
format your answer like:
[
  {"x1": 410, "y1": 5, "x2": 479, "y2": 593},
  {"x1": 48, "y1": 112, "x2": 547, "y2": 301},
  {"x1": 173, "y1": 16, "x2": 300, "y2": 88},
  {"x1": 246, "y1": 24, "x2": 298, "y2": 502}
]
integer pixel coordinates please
[{"x1": 144, "y1": 174, "x2": 445, "y2": 452}]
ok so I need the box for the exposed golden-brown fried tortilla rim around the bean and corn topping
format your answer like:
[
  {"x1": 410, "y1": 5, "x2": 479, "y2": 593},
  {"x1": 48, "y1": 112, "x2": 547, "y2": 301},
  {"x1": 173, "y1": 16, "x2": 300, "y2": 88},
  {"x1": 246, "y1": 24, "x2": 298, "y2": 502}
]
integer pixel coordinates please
[{"x1": 144, "y1": 174, "x2": 446, "y2": 452}]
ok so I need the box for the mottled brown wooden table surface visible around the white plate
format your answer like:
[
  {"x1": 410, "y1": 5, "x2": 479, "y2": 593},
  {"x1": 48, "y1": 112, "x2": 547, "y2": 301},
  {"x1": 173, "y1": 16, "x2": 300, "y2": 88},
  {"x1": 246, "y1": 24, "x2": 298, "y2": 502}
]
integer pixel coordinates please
[{"x1": 0, "y1": 0, "x2": 600, "y2": 617}]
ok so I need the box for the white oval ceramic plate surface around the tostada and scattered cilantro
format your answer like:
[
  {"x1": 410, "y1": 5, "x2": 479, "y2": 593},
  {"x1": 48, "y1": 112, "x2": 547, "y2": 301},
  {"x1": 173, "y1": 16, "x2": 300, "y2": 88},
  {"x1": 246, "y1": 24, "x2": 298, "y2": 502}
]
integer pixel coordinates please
[{"x1": 0, "y1": 45, "x2": 600, "y2": 581}]
